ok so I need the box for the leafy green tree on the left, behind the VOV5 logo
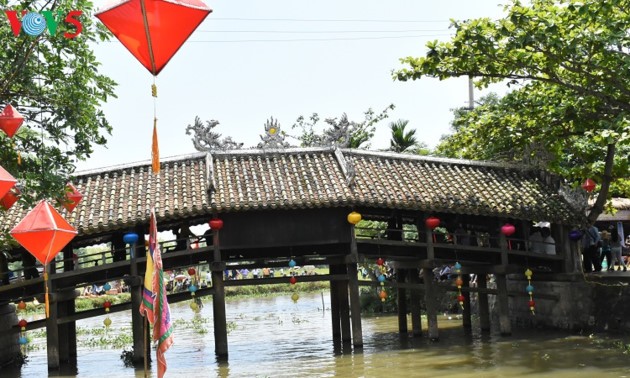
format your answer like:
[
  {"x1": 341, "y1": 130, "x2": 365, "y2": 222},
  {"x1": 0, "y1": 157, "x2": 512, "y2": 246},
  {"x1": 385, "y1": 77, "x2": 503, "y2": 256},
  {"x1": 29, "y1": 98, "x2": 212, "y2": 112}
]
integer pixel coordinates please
[{"x1": 0, "y1": 0, "x2": 115, "y2": 210}]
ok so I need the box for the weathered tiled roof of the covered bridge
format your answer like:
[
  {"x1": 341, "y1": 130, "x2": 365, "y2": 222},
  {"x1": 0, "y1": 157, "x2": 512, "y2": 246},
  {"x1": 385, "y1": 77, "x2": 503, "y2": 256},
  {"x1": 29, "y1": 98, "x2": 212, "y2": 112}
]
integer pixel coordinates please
[{"x1": 3, "y1": 148, "x2": 580, "y2": 234}]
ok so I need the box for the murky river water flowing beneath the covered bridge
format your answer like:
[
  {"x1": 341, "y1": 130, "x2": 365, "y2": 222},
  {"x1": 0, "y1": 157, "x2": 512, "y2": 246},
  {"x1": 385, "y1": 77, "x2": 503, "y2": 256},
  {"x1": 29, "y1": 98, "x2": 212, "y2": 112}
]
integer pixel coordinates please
[{"x1": 7, "y1": 293, "x2": 630, "y2": 378}]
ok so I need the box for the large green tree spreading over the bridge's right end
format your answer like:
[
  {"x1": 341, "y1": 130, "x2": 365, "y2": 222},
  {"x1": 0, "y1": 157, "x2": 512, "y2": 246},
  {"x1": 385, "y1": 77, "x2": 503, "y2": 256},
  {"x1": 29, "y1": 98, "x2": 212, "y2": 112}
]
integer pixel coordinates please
[{"x1": 394, "y1": 0, "x2": 630, "y2": 223}]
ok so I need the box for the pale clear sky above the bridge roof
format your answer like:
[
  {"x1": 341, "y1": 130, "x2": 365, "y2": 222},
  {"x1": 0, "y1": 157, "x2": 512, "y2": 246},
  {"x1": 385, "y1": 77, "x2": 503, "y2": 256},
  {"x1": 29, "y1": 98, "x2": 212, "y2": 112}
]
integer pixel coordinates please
[{"x1": 77, "y1": 0, "x2": 505, "y2": 172}]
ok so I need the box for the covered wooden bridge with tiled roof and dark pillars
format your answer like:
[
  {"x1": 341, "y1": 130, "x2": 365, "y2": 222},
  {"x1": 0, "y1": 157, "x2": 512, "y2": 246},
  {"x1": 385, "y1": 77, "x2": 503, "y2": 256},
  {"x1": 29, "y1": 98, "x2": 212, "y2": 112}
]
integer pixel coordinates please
[{"x1": 0, "y1": 148, "x2": 583, "y2": 368}]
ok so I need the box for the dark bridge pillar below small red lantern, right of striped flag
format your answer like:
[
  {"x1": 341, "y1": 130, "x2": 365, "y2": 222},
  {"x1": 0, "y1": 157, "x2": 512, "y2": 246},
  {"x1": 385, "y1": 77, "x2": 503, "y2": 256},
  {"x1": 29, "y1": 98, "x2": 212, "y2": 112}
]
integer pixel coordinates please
[{"x1": 212, "y1": 226, "x2": 228, "y2": 361}]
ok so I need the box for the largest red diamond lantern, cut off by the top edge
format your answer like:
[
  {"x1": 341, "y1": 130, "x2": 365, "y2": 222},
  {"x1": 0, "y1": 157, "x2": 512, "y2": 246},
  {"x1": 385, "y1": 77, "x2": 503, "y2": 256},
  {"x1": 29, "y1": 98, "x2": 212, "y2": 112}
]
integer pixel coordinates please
[{"x1": 96, "y1": 0, "x2": 212, "y2": 75}]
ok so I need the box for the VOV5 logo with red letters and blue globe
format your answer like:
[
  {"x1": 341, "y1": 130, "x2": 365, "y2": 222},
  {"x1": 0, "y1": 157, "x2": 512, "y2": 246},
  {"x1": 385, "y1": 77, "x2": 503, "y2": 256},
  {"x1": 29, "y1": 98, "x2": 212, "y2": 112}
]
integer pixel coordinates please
[{"x1": 4, "y1": 10, "x2": 83, "y2": 38}]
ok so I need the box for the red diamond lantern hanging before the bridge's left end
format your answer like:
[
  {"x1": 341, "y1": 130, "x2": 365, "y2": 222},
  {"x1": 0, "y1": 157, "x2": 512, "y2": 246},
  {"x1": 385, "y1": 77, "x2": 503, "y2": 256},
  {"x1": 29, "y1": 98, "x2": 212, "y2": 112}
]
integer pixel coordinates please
[{"x1": 11, "y1": 200, "x2": 77, "y2": 265}]
